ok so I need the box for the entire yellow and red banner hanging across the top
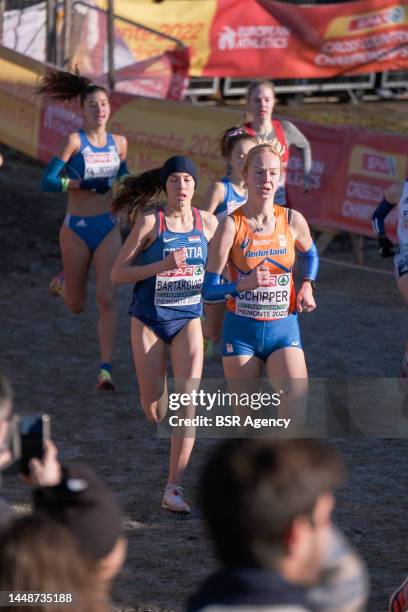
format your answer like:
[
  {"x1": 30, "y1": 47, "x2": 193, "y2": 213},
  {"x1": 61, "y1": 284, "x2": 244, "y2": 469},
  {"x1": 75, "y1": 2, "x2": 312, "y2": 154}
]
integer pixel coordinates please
[{"x1": 115, "y1": 0, "x2": 408, "y2": 79}]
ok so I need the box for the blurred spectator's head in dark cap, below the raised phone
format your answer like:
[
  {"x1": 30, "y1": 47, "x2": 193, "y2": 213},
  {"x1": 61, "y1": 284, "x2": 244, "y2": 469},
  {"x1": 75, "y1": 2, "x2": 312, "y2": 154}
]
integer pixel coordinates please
[{"x1": 34, "y1": 464, "x2": 126, "y2": 581}]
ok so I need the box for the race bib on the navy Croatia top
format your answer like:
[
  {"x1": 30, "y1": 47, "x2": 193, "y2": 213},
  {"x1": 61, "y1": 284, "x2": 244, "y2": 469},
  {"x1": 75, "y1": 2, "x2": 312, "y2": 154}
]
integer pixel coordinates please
[{"x1": 154, "y1": 265, "x2": 204, "y2": 306}]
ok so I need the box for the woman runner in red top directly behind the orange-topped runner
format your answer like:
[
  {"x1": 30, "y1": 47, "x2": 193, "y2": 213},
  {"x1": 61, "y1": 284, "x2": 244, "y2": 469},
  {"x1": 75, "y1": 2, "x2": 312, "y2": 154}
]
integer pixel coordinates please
[{"x1": 244, "y1": 81, "x2": 312, "y2": 206}]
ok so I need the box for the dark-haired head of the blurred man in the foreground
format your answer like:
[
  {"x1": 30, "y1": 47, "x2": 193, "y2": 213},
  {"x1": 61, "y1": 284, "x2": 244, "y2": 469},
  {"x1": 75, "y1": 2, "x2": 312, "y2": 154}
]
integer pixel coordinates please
[{"x1": 200, "y1": 439, "x2": 343, "y2": 584}]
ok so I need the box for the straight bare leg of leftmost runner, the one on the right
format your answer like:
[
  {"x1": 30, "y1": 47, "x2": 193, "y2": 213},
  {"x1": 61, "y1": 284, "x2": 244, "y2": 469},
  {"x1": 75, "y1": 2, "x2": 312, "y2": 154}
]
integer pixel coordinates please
[{"x1": 93, "y1": 225, "x2": 122, "y2": 363}]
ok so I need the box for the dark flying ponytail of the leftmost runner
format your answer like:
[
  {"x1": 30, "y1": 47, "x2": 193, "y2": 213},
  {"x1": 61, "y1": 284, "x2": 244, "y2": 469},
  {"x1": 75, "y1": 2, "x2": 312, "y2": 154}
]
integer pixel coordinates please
[{"x1": 37, "y1": 68, "x2": 108, "y2": 106}]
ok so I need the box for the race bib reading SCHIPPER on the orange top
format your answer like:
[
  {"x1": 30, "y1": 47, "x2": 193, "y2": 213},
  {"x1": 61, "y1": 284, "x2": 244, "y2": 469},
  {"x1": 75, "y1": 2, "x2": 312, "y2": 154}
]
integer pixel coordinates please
[{"x1": 235, "y1": 274, "x2": 291, "y2": 319}]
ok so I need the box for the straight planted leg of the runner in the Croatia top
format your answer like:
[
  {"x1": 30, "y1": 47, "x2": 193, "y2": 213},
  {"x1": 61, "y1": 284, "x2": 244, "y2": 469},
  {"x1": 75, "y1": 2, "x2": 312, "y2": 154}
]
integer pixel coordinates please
[{"x1": 168, "y1": 319, "x2": 204, "y2": 485}]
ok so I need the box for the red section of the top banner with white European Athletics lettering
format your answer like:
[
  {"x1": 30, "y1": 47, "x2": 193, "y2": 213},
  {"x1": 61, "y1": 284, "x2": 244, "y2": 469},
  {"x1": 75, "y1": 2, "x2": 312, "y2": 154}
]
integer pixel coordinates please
[{"x1": 203, "y1": 0, "x2": 408, "y2": 79}]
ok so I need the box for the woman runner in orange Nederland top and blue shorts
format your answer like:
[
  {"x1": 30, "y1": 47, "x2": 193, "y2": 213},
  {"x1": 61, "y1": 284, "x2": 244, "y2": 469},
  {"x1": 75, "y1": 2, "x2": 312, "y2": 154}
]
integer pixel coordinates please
[{"x1": 204, "y1": 140, "x2": 318, "y2": 424}]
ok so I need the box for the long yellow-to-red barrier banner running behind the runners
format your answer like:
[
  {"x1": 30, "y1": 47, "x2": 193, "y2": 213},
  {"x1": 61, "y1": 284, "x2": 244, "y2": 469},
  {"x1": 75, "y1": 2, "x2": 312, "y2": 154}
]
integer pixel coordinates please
[{"x1": 0, "y1": 42, "x2": 408, "y2": 236}]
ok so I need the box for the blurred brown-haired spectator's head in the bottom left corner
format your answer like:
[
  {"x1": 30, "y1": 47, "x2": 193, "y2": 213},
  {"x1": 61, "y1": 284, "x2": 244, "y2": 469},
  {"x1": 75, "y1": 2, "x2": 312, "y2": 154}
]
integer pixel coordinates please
[{"x1": 0, "y1": 516, "x2": 109, "y2": 612}]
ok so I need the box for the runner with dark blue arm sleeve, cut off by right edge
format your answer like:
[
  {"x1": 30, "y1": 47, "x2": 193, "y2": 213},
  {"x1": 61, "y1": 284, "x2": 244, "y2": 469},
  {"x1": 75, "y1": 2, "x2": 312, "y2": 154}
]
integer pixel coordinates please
[{"x1": 373, "y1": 179, "x2": 408, "y2": 386}]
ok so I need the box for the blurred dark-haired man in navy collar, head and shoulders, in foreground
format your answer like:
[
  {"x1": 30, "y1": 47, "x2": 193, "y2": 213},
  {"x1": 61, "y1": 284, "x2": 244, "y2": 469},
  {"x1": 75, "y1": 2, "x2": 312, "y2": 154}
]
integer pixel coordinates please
[{"x1": 188, "y1": 439, "x2": 367, "y2": 612}]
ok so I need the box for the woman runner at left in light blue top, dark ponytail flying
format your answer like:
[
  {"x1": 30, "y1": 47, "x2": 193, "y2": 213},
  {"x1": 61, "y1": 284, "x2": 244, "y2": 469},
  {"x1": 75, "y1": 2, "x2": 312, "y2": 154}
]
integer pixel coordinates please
[{"x1": 39, "y1": 71, "x2": 129, "y2": 390}]
